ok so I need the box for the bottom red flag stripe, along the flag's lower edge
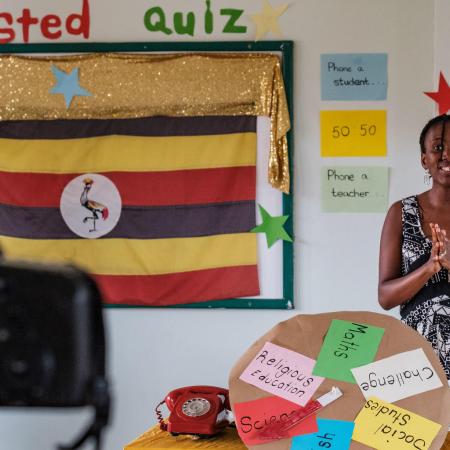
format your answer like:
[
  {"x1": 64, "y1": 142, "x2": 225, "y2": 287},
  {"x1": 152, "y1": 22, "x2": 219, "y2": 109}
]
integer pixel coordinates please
[{"x1": 92, "y1": 265, "x2": 259, "y2": 306}]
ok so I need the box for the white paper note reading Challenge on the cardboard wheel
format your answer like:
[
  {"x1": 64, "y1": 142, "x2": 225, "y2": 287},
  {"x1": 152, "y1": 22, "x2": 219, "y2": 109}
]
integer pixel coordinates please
[{"x1": 351, "y1": 348, "x2": 442, "y2": 403}]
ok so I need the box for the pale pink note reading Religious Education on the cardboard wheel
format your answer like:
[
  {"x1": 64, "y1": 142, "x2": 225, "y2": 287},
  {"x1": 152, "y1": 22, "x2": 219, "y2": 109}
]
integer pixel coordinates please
[{"x1": 239, "y1": 342, "x2": 324, "y2": 406}]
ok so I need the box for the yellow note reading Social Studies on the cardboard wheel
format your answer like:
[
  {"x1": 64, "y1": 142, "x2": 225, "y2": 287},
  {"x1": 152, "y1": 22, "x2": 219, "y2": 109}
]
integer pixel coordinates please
[{"x1": 352, "y1": 397, "x2": 441, "y2": 450}]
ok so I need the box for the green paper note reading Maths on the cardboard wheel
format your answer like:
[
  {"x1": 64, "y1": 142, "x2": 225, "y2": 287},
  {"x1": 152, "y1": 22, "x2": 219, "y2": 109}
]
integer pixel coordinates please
[{"x1": 313, "y1": 319, "x2": 384, "y2": 383}]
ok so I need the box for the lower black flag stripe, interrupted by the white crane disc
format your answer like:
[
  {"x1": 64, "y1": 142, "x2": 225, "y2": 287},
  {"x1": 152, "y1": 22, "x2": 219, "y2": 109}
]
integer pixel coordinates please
[{"x1": 0, "y1": 201, "x2": 256, "y2": 239}]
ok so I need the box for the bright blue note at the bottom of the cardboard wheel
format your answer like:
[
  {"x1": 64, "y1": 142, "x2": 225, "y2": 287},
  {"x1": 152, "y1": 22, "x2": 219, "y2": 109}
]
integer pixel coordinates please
[{"x1": 291, "y1": 419, "x2": 355, "y2": 450}]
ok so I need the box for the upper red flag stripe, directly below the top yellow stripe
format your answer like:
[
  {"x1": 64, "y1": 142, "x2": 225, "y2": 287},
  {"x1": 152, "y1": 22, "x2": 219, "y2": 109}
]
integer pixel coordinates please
[{"x1": 0, "y1": 166, "x2": 256, "y2": 208}]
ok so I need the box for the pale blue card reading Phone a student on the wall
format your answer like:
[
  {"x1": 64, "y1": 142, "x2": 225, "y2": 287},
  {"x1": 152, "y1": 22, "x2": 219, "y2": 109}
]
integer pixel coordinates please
[{"x1": 320, "y1": 53, "x2": 387, "y2": 100}]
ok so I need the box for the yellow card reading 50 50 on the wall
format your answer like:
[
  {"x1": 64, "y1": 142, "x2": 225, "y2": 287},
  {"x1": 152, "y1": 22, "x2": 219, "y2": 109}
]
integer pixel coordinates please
[{"x1": 320, "y1": 110, "x2": 387, "y2": 157}]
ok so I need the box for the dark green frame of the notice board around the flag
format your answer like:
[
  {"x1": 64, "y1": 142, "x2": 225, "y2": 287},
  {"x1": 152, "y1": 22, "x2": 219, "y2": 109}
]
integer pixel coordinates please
[{"x1": 0, "y1": 41, "x2": 294, "y2": 309}]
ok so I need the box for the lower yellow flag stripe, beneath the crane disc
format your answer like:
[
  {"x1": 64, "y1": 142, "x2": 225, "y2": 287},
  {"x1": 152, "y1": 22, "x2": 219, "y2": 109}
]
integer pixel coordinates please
[{"x1": 0, "y1": 233, "x2": 257, "y2": 275}]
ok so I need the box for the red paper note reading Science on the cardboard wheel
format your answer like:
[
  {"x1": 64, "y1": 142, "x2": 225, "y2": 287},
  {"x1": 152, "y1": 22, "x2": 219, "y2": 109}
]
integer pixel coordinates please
[{"x1": 234, "y1": 397, "x2": 318, "y2": 445}]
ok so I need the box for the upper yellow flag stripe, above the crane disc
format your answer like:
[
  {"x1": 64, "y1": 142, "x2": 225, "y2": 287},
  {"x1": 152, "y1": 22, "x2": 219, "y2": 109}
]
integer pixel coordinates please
[{"x1": 0, "y1": 133, "x2": 256, "y2": 173}]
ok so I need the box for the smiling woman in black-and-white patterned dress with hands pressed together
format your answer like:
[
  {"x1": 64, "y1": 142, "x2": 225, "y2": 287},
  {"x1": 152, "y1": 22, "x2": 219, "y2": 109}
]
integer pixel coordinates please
[{"x1": 378, "y1": 115, "x2": 450, "y2": 380}]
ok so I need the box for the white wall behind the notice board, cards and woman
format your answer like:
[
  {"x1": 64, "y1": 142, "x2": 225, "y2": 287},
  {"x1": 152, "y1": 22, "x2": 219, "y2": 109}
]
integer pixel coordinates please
[{"x1": 0, "y1": 0, "x2": 438, "y2": 450}]
